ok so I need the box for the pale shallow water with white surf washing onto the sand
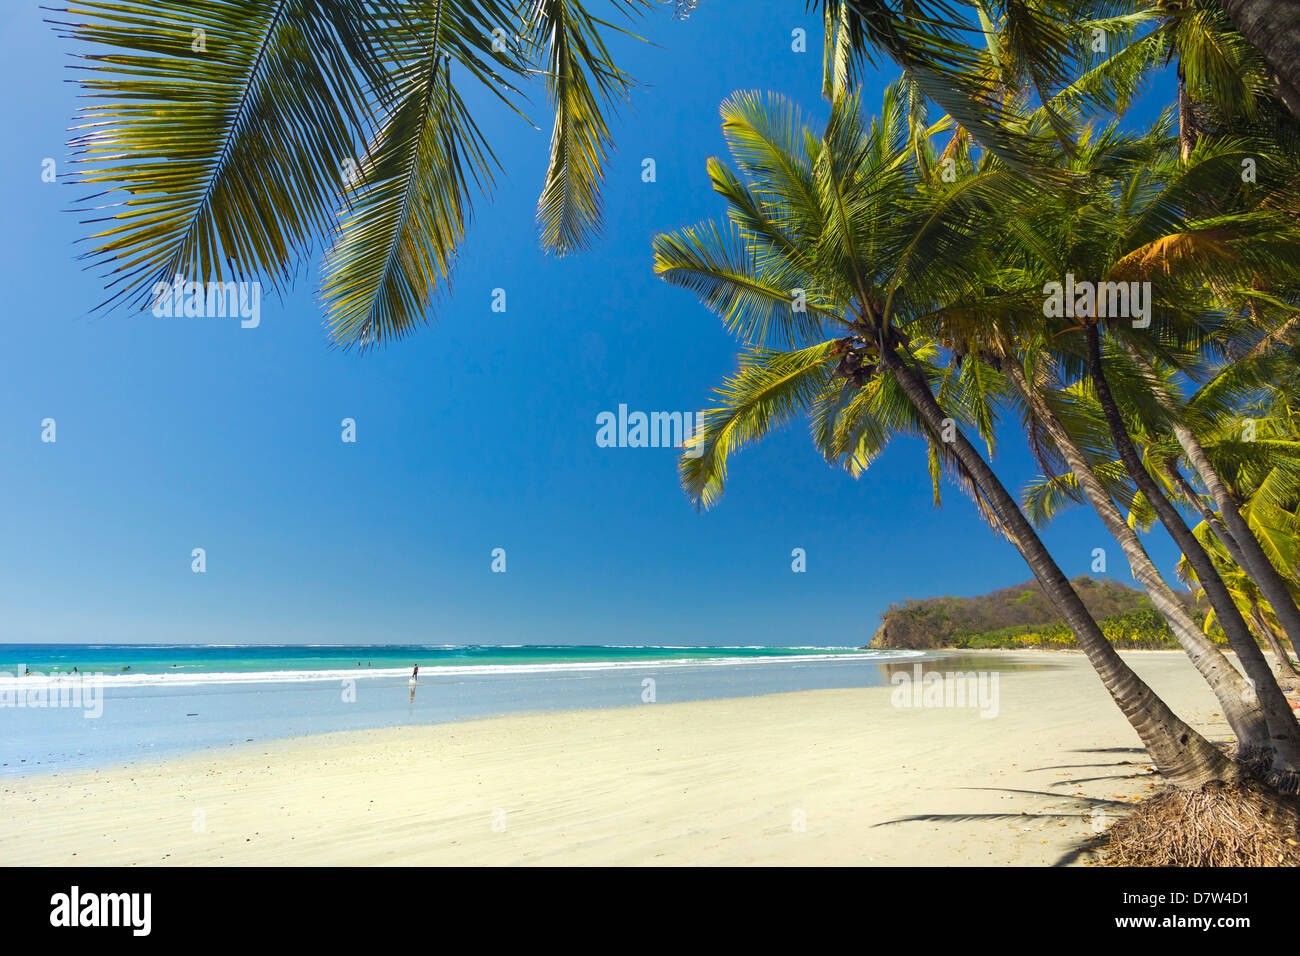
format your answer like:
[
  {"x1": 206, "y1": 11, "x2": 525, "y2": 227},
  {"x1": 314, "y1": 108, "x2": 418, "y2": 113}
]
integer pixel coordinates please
[{"x1": 0, "y1": 648, "x2": 1055, "y2": 775}]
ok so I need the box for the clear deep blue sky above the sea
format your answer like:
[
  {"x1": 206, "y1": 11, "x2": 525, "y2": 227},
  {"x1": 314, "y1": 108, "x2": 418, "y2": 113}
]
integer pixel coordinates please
[{"x1": 0, "y1": 0, "x2": 1177, "y2": 644}]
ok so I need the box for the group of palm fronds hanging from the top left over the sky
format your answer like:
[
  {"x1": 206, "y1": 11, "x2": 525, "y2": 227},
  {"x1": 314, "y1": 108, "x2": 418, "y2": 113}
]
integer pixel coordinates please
[{"x1": 53, "y1": 0, "x2": 650, "y2": 349}]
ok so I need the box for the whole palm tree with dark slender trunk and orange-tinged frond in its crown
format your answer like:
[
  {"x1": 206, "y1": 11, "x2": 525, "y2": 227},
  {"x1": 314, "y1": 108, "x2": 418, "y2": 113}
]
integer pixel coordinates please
[{"x1": 961, "y1": 115, "x2": 1300, "y2": 788}]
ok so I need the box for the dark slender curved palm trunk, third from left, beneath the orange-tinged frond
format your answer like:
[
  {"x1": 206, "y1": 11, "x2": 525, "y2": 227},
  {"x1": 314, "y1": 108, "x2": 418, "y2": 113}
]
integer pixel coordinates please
[{"x1": 1087, "y1": 323, "x2": 1300, "y2": 791}]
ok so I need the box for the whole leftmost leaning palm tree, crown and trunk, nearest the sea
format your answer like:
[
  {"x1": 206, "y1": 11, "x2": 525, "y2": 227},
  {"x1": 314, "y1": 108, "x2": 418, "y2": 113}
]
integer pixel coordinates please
[{"x1": 654, "y1": 82, "x2": 1239, "y2": 787}]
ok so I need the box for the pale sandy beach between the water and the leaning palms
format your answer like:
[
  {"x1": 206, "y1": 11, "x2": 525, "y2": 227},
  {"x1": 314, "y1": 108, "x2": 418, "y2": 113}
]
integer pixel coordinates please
[{"x1": 0, "y1": 652, "x2": 1229, "y2": 865}]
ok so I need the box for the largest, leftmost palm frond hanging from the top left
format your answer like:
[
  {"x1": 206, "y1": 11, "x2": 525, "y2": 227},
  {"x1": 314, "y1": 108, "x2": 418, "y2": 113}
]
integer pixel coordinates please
[{"x1": 57, "y1": 0, "x2": 374, "y2": 304}]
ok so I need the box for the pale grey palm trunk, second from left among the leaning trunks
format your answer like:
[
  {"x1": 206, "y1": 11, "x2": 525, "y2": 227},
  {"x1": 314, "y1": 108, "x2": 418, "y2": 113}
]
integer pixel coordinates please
[{"x1": 1002, "y1": 359, "x2": 1273, "y2": 762}]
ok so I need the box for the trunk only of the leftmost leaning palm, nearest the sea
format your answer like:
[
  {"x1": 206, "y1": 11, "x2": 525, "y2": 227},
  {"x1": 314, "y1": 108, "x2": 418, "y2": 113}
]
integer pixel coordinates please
[{"x1": 881, "y1": 345, "x2": 1240, "y2": 788}]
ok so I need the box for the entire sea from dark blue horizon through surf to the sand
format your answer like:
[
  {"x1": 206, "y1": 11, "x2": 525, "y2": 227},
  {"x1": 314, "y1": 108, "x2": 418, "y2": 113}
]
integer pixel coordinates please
[{"x1": 0, "y1": 644, "x2": 924, "y2": 775}]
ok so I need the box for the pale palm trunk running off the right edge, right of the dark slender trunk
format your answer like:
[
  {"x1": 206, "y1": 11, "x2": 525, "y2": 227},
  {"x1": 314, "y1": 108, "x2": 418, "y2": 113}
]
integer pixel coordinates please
[{"x1": 1130, "y1": 350, "x2": 1300, "y2": 654}]
